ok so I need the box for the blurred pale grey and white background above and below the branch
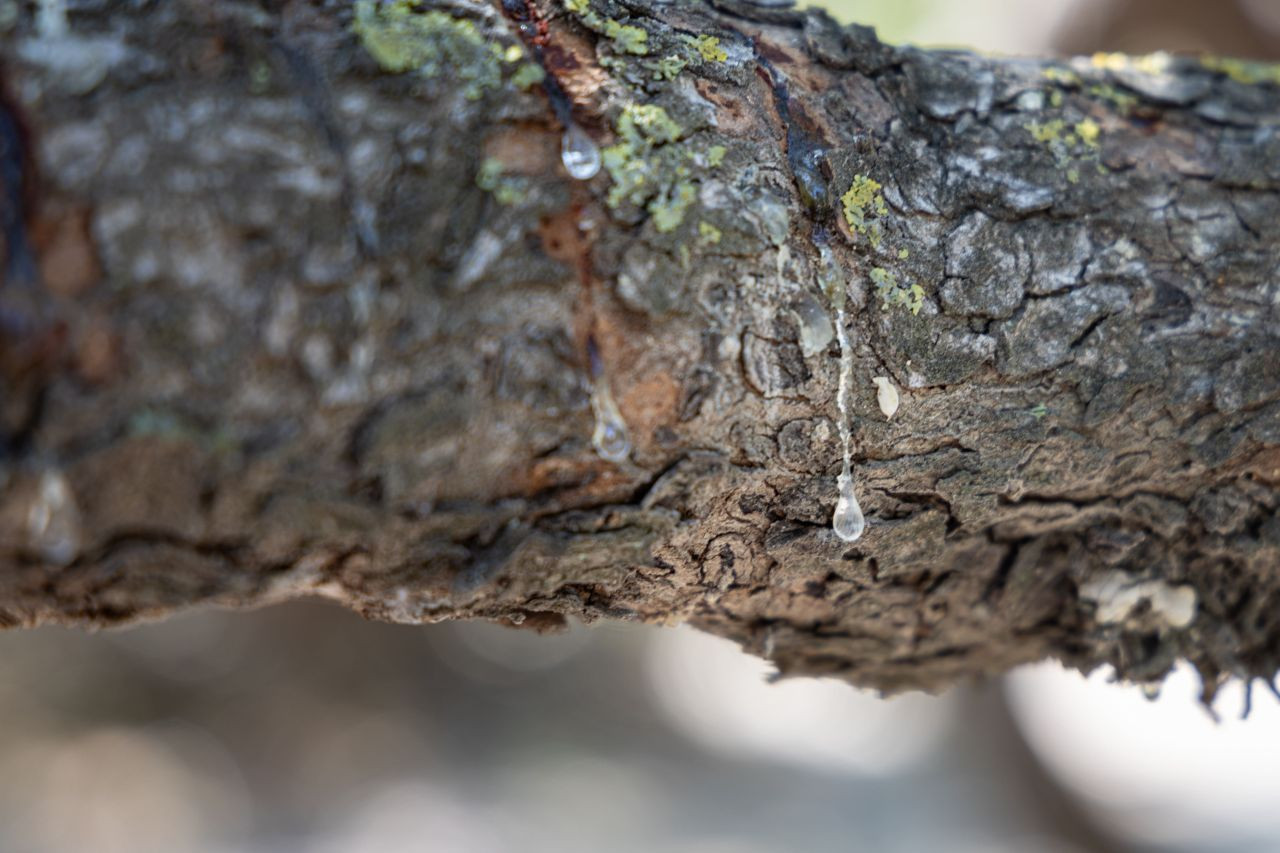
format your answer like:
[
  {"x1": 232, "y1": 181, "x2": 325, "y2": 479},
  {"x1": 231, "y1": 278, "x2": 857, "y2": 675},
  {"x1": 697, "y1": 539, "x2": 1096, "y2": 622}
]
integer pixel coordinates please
[{"x1": 0, "y1": 0, "x2": 1280, "y2": 853}]
